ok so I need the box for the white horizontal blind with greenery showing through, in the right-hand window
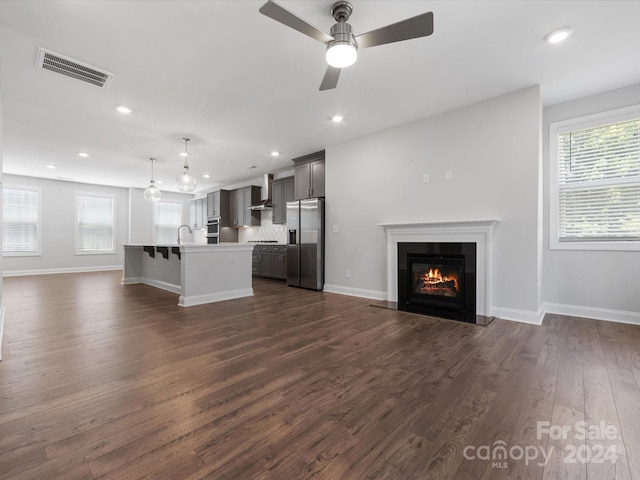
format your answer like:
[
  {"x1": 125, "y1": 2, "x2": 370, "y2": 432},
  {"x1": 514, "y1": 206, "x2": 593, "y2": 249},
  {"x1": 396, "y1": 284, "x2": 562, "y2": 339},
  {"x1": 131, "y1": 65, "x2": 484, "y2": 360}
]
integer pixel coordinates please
[{"x1": 557, "y1": 120, "x2": 640, "y2": 242}]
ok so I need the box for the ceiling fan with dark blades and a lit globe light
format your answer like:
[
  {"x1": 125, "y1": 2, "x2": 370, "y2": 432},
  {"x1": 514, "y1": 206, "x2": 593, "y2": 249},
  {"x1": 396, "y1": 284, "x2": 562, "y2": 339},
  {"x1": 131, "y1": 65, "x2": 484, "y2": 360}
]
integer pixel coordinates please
[{"x1": 259, "y1": 0, "x2": 433, "y2": 90}]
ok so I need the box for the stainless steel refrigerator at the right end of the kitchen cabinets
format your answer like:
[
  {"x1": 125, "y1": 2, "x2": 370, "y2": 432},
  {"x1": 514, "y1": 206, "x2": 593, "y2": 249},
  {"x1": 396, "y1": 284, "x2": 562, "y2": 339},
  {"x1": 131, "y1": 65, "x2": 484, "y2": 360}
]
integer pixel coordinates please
[{"x1": 287, "y1": 198, "x2": 324, "y2": 290}]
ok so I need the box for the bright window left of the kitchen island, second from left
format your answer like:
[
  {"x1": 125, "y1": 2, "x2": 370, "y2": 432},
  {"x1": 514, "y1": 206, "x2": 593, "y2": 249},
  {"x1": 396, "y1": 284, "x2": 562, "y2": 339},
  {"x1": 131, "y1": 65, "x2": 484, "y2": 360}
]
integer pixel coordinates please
[{"x1": 76, "y1": 194, "x2": 115, "y2": 254}]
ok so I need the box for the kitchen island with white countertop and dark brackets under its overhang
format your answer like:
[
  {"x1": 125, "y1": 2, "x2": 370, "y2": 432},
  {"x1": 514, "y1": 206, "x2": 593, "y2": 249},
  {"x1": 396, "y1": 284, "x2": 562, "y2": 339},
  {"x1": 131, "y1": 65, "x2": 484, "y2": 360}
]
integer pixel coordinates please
[{"x1": 122, "y1": 243, "x2": 253, "y2": 307}]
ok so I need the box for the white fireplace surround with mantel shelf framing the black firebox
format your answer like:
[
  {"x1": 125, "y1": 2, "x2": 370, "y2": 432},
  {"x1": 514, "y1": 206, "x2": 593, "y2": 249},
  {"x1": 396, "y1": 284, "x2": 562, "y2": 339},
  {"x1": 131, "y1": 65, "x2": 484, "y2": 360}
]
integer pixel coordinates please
[{"x1": 380, "y1": 219, "x2": 499, "y2": 316}]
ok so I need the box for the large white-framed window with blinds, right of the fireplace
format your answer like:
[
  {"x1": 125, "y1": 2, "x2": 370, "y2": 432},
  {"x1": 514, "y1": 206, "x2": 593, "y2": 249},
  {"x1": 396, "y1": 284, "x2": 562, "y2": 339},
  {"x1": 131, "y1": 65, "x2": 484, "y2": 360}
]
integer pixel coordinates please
[{"x1": 549, "y1": 107, "x2": 640, "y2": 250}]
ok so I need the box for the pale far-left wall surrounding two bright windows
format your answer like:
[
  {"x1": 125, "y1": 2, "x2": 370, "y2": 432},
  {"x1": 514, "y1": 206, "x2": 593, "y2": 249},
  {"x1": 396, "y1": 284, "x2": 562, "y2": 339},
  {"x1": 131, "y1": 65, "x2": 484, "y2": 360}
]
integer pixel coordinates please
[{"x1": 3, "y1": 175, "x2": 129, "y2": 275}]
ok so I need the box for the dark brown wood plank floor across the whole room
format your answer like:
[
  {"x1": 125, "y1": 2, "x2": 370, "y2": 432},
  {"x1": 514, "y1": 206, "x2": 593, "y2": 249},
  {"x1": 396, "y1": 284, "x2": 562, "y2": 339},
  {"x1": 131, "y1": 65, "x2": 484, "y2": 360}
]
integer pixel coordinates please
[{"x1": 0, "y1": 272, "x2": 640, "y2": 480}]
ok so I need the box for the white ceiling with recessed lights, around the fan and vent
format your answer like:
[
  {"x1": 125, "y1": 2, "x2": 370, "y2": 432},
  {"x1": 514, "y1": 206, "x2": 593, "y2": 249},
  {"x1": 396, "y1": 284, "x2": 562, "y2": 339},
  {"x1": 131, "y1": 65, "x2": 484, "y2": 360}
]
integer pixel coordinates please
[{"x1": 0, "y1": 0, "x2": 640, "y2": 191}]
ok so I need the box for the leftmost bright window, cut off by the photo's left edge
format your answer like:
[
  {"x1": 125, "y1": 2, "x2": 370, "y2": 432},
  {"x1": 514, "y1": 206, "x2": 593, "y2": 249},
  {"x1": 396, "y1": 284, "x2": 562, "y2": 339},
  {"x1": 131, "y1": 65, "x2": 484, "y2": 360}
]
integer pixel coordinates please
[{"x1": 2, "y1": 187, "x2": 40, "y2": 256}]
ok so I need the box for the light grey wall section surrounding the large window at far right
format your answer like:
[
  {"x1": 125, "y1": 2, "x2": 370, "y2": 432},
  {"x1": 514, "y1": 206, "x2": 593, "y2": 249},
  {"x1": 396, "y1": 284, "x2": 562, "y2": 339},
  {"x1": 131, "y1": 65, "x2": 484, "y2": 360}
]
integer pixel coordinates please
[{"x1": 543, "y1": 85, "x2": 640, "y2": 323}]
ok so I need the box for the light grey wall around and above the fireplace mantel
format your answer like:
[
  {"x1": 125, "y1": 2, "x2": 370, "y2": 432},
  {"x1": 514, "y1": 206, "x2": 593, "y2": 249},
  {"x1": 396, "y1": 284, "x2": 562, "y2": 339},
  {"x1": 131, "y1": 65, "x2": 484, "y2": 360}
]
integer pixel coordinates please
[{"x1": 325, "y1": 87, "x2": 541, "y2": 322}]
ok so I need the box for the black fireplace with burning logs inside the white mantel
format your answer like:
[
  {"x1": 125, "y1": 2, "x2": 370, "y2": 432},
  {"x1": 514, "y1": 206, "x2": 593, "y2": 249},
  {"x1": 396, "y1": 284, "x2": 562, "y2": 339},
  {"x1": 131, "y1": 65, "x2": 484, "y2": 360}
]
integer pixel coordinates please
[{"x1": 398, "y1": 242, "x2": 476, "y2": 323}]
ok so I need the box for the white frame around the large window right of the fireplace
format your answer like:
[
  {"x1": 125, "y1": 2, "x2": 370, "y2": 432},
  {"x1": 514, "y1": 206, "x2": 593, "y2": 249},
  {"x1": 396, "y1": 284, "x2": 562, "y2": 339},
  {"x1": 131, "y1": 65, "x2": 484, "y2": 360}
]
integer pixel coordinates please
[{"x1": 549, "y1": 105, "x2": 640, "y2": 251}]
